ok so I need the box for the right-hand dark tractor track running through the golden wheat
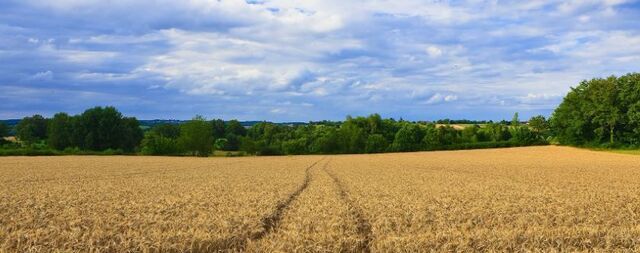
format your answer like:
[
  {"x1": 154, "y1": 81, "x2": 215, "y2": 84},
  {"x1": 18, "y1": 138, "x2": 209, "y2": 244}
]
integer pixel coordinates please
[{"x1": 322, "y1": 162, "x2": 373, "y2": 253}]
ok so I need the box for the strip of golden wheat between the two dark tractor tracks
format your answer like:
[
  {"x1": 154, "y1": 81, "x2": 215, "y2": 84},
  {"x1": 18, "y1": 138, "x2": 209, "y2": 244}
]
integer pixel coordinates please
[{"x1": 246, "y1": 160, "x2": 367, "y2": 252}]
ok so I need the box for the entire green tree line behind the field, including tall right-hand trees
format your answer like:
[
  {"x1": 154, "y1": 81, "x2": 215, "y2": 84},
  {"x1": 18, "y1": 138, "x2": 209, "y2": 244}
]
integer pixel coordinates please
[{"x1": 0, "y1": 73, "x2": 640, "y2": 156}]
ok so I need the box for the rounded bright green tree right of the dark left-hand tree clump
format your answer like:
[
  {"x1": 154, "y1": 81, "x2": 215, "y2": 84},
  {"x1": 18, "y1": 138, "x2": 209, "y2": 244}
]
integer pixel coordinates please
[{"x1": 178, "y1": 115, "x2": 213, "y2": 156}]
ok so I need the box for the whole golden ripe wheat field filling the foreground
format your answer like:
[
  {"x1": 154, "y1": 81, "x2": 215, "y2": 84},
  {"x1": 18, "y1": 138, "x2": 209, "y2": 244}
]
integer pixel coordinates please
[{"x1": 0, "y1": 146, "x2": 640, "y2": 252}]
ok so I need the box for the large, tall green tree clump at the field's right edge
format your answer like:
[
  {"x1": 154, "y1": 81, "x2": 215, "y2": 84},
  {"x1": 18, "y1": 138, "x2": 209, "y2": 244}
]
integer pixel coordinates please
[{"x1": 550, "y1": 73, "x2": 640, "y2": 145}]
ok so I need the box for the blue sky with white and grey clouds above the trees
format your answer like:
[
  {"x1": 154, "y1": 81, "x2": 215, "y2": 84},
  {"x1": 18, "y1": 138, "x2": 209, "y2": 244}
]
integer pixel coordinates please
[{"x1": 0, "y1": 0, "x2": 640, "y2": 121}]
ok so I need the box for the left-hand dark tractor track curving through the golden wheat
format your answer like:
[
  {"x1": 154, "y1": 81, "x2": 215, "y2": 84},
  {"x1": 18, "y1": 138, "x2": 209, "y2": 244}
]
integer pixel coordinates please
[{"x1": 204, "y1": 157, "x2": 326, "y2": 252}]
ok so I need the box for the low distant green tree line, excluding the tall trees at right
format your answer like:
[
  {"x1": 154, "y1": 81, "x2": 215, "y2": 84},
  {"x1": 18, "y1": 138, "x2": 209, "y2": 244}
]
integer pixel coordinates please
[{"x1": 0, "y1": 107, "x2": 549, "y2": 156}]
